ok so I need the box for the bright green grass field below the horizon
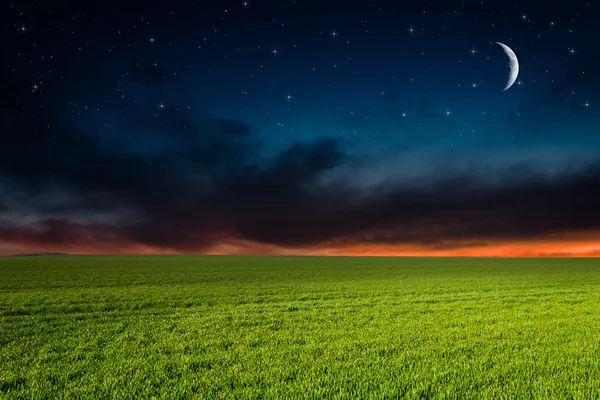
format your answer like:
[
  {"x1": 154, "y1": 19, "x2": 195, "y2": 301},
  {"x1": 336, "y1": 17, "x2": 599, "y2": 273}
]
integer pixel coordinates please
[{"x1": 0, "y1": 256, "x2": 600, "y2": 399}]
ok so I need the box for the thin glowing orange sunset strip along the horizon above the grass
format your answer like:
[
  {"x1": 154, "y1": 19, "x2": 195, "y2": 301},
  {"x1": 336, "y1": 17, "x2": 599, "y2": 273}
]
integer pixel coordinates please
[{"x1": 0, "y1": 223, "x2": 600, "y2": 257}]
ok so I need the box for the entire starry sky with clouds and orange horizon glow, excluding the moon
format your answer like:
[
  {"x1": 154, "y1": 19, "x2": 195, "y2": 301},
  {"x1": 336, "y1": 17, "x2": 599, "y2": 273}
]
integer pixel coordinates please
[{"x1": 0, "y1": 0, "x2": 600, "y2": 256}]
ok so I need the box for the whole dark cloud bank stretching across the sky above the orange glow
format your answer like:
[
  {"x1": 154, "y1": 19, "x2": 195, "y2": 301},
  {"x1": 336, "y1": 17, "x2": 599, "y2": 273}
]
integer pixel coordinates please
[{"x1": 0, "y1": 101, "x2": 600, "y2": 251}]
